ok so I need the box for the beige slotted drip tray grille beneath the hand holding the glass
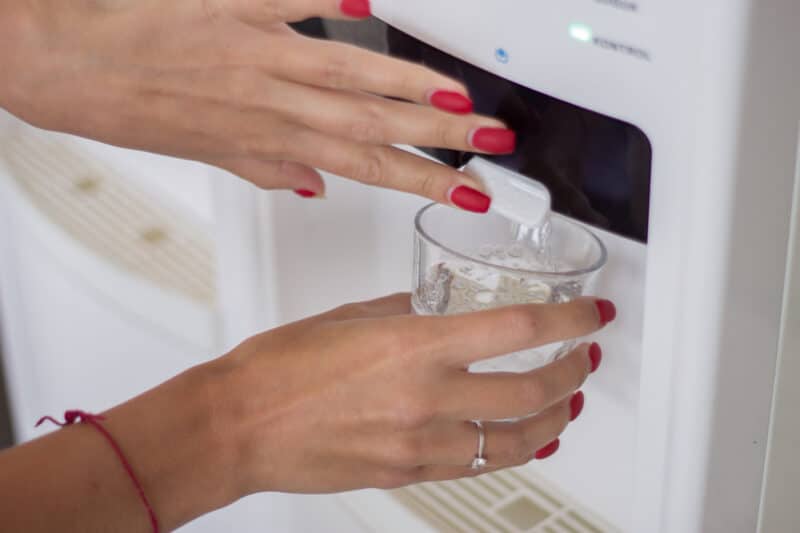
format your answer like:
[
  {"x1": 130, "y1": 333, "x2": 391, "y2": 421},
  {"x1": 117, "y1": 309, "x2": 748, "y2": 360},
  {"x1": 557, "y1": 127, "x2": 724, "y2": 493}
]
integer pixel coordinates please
[{"x1": 393, "y1": 469, "x2": 619, "y2": 533}]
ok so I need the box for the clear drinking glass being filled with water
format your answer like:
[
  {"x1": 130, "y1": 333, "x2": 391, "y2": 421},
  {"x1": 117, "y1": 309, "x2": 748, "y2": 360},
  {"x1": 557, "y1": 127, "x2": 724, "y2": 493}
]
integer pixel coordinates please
[{"x1": 412, "y1": 204, "x2": 606, "y2": 372}]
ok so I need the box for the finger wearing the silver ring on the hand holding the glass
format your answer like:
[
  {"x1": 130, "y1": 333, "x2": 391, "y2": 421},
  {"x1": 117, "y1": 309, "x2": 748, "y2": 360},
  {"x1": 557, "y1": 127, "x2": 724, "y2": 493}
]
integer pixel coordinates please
[{"x1": 409, "y1": 397, "x2": 571, "y2": 467}]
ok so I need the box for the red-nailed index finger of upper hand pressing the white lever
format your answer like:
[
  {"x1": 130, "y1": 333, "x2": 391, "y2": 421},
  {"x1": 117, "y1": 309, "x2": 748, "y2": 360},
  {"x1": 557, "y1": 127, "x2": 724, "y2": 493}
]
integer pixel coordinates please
[{"x1": 284, "y1": 126, "x2": 491, "y2": 213}]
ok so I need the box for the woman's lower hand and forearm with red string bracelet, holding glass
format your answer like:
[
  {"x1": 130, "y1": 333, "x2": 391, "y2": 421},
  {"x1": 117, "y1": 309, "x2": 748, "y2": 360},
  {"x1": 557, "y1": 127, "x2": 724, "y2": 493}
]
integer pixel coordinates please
[{"x1": 0, "y1": 294, "x2": 608, "y2": 532}]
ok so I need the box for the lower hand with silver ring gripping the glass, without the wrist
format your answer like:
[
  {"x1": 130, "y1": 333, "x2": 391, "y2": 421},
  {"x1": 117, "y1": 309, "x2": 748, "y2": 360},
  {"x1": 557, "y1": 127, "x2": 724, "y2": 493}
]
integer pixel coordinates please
[{"x1": 215, "y1": 294, "x2": 609, "y2": 494}]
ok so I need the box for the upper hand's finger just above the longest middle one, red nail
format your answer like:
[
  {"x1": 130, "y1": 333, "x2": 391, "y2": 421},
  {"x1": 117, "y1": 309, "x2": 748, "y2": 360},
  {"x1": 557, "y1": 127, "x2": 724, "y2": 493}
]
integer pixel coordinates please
[{"x1": 264, "y1": 36, "x2": 472, "y2": 105}]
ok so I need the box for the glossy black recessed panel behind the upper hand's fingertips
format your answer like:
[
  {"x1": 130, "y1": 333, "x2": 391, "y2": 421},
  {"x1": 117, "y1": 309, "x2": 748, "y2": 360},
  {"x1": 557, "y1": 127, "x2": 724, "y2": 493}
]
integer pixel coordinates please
[{"x1": 296, "y1": 20, "x2": 652, "y2": 242}]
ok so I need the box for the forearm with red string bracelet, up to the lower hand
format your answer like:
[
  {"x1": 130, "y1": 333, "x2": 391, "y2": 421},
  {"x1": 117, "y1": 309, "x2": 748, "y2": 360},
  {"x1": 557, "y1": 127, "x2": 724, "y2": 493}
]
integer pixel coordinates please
[{"x1": 0, "y1": 363, "x2": 240, "y2": 532}]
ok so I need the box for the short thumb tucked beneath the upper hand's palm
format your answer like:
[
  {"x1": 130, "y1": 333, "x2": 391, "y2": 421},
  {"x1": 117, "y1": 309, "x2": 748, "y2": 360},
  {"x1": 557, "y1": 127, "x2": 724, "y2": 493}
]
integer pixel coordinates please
[{"x1": 211, "y1": 157, "x2": 325, "y2": 197}]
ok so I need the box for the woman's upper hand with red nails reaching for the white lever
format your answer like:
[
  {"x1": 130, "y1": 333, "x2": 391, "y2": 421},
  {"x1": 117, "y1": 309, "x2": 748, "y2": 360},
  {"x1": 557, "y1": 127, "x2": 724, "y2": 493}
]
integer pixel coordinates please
[{"x1": 0, "y1": 0, "x2": 515, "y2": 211}]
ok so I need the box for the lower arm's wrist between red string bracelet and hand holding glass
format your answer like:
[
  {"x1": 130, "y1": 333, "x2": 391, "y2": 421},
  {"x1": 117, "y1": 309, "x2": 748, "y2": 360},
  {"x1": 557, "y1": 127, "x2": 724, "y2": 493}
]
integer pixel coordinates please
[{"x1": 106, "y1": 362, "x2": 243, "y2": 530}]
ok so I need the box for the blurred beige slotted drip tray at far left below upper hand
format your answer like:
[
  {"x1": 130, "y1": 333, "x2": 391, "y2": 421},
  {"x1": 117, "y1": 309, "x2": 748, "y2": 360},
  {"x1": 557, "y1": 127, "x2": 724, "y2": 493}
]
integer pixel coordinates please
[{"x1": 0, "y1": 128, "x2": 215, "y2": 305}]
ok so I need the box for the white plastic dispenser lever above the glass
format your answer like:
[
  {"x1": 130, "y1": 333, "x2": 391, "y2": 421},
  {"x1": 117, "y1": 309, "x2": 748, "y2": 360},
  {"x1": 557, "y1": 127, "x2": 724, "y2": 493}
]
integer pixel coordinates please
[{"x1": 461, "y1": 157, "x2": 551, "y2": 228}]
